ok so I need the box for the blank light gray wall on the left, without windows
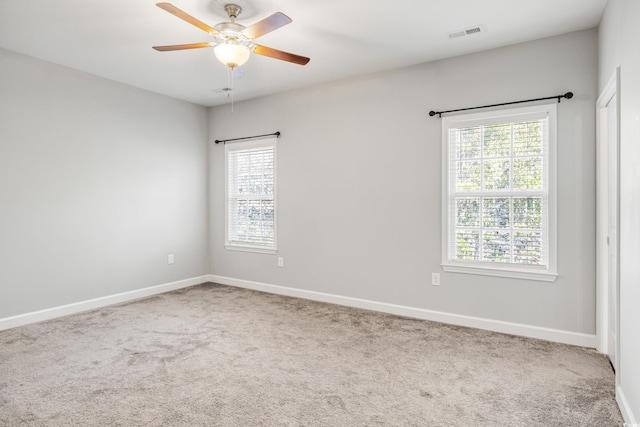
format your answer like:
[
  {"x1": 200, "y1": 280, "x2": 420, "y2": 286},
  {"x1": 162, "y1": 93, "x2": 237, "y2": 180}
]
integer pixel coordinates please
[{"x1": 0, "y1": 50, "x2": 208, "y2": 318}]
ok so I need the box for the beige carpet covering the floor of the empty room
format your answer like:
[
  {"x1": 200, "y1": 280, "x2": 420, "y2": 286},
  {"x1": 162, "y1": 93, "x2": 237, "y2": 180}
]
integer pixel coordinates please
[{"x1": 0, "y1": 284, "x2": 622, "y2": 427}]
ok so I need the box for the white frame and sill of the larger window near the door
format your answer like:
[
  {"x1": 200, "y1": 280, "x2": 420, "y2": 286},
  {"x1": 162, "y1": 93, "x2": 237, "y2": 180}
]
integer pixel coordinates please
[{"x1": 441, "y1": 104, "x2": 558, "y2": 282}]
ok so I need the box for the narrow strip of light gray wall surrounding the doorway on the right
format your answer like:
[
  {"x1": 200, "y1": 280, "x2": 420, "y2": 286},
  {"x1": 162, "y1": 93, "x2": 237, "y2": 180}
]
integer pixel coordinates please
[{"x1": 599, "y1": 0, "x2": 640, "y2": 423}]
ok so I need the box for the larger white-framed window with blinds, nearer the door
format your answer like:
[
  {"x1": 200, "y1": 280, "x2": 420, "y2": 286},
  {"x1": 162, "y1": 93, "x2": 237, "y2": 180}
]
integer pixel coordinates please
[{"x1": 442, "y1": 104, "x2": 557, "y2": 281}]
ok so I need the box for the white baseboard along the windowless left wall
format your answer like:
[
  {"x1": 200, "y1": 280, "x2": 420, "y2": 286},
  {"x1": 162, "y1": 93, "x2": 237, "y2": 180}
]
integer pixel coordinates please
[{"x1": 0, "y1": 276, "x2": 208, "y2": 331}]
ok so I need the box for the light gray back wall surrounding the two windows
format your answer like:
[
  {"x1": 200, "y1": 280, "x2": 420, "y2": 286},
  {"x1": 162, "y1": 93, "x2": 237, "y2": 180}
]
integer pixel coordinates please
[{"x1": 210, "y1": 30, "x2": 598, "y2": 334}]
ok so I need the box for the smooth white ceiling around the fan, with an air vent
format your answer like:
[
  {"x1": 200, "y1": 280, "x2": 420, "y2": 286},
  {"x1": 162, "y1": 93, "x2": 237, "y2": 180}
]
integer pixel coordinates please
[{"x1": 0, "y1": 0, "x2": 607, "y2": 106}]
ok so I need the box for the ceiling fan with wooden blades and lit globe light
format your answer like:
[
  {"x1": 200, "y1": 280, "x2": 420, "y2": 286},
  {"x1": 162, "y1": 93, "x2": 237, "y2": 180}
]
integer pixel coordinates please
[{"x1": 153, "y1": 3, "x2": 310, "y2": 70}]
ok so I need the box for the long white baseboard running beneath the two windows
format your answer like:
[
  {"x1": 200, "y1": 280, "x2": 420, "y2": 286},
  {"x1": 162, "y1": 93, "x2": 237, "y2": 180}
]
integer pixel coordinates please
[{"x1": 208, "y1": 275, "x2": 597, "y2": 348}]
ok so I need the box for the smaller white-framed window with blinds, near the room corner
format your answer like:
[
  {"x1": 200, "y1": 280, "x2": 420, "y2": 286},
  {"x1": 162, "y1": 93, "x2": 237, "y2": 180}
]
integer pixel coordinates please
[{"x1": 225, "y1": 138, "x2": 276, "y2": 253}]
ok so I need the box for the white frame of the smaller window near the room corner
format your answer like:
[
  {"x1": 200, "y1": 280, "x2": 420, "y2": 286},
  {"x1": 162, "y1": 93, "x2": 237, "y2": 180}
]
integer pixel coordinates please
[{"x1": 225, "y1": 137, "x2": 278, "y2": 254}]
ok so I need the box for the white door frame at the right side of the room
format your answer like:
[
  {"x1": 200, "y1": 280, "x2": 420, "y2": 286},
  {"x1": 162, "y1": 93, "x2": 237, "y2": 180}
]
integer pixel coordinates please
[{"x1": 596, "y1": 68, "x2": 620, "y2": 372}]
